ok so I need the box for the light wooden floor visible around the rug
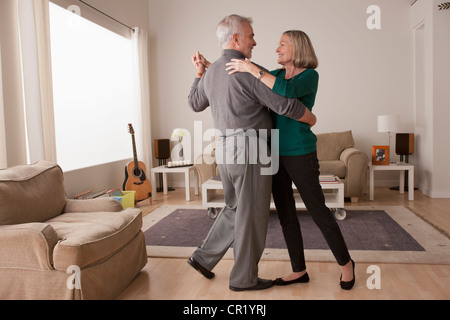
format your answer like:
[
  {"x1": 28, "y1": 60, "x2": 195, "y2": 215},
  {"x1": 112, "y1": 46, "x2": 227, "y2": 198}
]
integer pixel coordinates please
[{"x1": 117, "y1": 188, "x2": 450, "y2": 300}]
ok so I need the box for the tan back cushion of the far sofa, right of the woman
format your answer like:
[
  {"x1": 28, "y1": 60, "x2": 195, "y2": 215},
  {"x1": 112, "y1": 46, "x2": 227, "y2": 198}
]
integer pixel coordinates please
[{"x1": 317, "y1": 131, "x2": 355, "y2": 161}]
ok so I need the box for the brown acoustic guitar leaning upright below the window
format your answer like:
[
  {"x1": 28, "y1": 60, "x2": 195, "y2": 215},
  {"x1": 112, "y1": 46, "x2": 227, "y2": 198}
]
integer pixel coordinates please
[{"x1": 123, "y1": 123, "x2": 152, "y2": 203}]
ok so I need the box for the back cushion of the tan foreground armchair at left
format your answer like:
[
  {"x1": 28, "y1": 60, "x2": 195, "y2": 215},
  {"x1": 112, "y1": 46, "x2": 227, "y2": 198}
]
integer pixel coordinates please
[{"x1": 0, "y1": 161, "x2": 66, "y2": 225}]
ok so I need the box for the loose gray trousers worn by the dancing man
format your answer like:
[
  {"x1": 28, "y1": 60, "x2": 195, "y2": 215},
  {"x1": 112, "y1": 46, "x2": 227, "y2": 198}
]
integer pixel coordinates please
[{"x1": 192, "y1": 134, "x2": 272, "y2": 288}]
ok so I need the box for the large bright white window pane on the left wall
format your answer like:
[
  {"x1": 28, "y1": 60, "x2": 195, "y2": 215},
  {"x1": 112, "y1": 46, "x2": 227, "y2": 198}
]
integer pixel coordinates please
[{"x1": 50, "y1": 3, "x2": 135, "y2": 171}]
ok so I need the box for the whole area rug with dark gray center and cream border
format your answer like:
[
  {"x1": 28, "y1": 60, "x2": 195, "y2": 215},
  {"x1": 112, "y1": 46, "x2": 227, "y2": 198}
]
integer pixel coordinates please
[{"x1": 142, "y1": 205, "x2": 450, "y2": 264}]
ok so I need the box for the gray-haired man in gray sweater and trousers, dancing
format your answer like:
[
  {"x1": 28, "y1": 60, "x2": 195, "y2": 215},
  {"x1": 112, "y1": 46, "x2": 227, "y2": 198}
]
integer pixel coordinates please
[{"x1": 188, "y1": 15, "x2": 316, "y2": 291}]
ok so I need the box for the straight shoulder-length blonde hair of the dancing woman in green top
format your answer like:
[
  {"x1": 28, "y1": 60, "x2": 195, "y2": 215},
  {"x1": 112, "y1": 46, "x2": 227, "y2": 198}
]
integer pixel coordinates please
[{"x1": 283, "y1": 30, "x2": 319, "y2": 69}]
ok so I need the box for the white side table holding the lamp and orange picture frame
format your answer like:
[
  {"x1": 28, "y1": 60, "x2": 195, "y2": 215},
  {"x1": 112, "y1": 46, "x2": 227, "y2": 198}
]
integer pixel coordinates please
[{"x1": 369, "y1": 162, "x2": 414, "y2": 201}]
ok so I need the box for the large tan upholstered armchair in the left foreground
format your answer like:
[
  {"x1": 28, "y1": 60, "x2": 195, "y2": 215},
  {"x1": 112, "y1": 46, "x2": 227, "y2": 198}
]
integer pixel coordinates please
[{"x1": 0, "y1": 161, "x2": 147, "y2": 300}]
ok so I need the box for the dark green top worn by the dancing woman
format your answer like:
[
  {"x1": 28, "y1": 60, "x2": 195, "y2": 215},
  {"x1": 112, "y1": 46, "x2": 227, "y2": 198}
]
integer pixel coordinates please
[{"x1": 271, "y1": 69, "x2": 319, "y2": 156}]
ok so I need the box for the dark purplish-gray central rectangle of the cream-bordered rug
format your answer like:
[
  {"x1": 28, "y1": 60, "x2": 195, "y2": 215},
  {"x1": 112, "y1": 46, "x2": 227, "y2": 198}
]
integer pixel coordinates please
[{"x1": 144, "y1": 209, "x2": 425, "y2": 251}]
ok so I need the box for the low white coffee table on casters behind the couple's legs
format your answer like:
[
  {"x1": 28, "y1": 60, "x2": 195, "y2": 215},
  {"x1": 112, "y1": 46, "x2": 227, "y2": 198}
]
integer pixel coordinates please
[{"x1": 202, "y1": 177, "x2": 347, "y2": 220}]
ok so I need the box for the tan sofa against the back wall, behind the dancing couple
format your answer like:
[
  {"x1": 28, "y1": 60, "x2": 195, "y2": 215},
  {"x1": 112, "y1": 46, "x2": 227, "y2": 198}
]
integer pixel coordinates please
[{"x1": 195, "y1": 131, "x2": 369, "y2": 202}]
